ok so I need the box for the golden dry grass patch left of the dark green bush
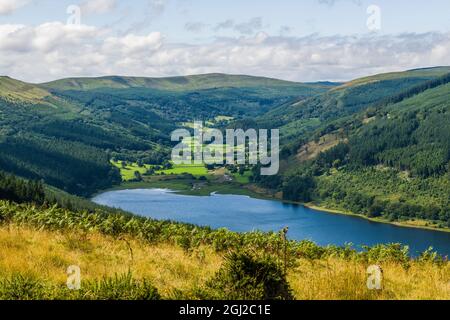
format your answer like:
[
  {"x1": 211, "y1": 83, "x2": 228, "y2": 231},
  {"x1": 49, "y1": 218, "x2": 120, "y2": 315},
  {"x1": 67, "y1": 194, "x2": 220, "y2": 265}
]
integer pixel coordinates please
[{"x1": 0, "y1": 226, "x2": 221, "y2": 296}]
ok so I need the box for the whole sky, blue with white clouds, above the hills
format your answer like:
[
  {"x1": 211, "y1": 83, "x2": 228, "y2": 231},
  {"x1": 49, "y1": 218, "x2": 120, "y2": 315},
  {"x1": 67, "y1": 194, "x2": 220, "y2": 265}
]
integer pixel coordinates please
[{"x1": 0, "y1": 0, "x2": 450, "y2": 82}]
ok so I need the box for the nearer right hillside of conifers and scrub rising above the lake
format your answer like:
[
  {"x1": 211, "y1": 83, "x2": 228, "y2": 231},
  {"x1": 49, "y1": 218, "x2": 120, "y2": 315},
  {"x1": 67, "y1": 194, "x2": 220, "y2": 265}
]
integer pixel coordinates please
[{"x1": 253, "y1": 71, "x2": 450, "y2": 227}]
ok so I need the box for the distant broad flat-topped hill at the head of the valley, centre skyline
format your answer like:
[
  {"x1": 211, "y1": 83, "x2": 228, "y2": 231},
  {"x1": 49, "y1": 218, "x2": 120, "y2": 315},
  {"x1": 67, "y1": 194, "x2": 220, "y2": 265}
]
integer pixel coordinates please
[{"x1": 42, "y1": 74, "x2": 334, "y2": 122}]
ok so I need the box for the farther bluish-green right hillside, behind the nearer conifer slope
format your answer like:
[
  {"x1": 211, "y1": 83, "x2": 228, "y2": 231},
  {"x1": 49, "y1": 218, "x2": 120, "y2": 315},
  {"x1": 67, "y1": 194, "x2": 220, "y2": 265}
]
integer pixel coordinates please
[{"x1": 258, "y1": 67, "x2": 450, "y2": 140}]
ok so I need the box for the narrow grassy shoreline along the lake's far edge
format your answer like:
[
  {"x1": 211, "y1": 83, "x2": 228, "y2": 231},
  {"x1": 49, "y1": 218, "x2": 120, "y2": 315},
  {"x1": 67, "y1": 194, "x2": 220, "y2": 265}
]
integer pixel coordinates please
[{"x1": 94, "y1": 180, "x2": 450, "y2": 233}]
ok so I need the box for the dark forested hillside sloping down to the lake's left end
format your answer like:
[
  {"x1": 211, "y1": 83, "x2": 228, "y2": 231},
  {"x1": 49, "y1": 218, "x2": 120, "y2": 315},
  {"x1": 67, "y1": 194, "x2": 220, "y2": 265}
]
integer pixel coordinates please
[{"x1": 0, "y1": 77, "x2": 170, "y2": 195}]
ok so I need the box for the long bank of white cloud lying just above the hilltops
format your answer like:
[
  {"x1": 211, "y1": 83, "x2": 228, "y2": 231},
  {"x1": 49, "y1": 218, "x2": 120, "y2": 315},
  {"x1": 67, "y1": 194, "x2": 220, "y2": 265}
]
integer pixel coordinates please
[{"x1": 0, "y1": 22, "x2": 450, "y2": 82}]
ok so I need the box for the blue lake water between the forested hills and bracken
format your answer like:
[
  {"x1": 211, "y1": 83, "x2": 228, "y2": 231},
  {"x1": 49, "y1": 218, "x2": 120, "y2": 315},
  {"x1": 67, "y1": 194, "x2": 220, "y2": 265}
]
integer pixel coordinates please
[{"x1": 93, "y1": 189, "x2": 450, "y2": 256}]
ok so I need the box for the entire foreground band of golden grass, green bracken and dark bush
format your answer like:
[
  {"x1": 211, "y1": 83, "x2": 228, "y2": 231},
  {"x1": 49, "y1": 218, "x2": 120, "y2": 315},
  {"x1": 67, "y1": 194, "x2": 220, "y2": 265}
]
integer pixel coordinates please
[{"x1": 0, "y1": 201, "x2": 450, "y2": 300}]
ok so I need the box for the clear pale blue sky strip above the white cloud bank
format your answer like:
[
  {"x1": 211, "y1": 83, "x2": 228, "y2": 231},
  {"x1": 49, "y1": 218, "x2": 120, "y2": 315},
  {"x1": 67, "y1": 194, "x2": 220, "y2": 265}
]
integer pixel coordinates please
[{"x1": 6, "y1": 0, "x2": 450, "y2": 38}]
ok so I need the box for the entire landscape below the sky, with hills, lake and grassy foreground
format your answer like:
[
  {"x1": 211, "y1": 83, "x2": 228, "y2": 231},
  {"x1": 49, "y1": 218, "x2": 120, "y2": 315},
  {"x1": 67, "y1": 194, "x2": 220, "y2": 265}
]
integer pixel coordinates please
[{"x1": 0, "y1": 67, "x2": 450, "y2": 299}]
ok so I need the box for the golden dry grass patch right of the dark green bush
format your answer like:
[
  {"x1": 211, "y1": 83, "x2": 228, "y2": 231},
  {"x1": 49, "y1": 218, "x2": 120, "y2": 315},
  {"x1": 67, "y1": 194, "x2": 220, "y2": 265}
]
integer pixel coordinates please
[{"x1": 289, "y1": 259, "x2": 450, "y2": 300}]
